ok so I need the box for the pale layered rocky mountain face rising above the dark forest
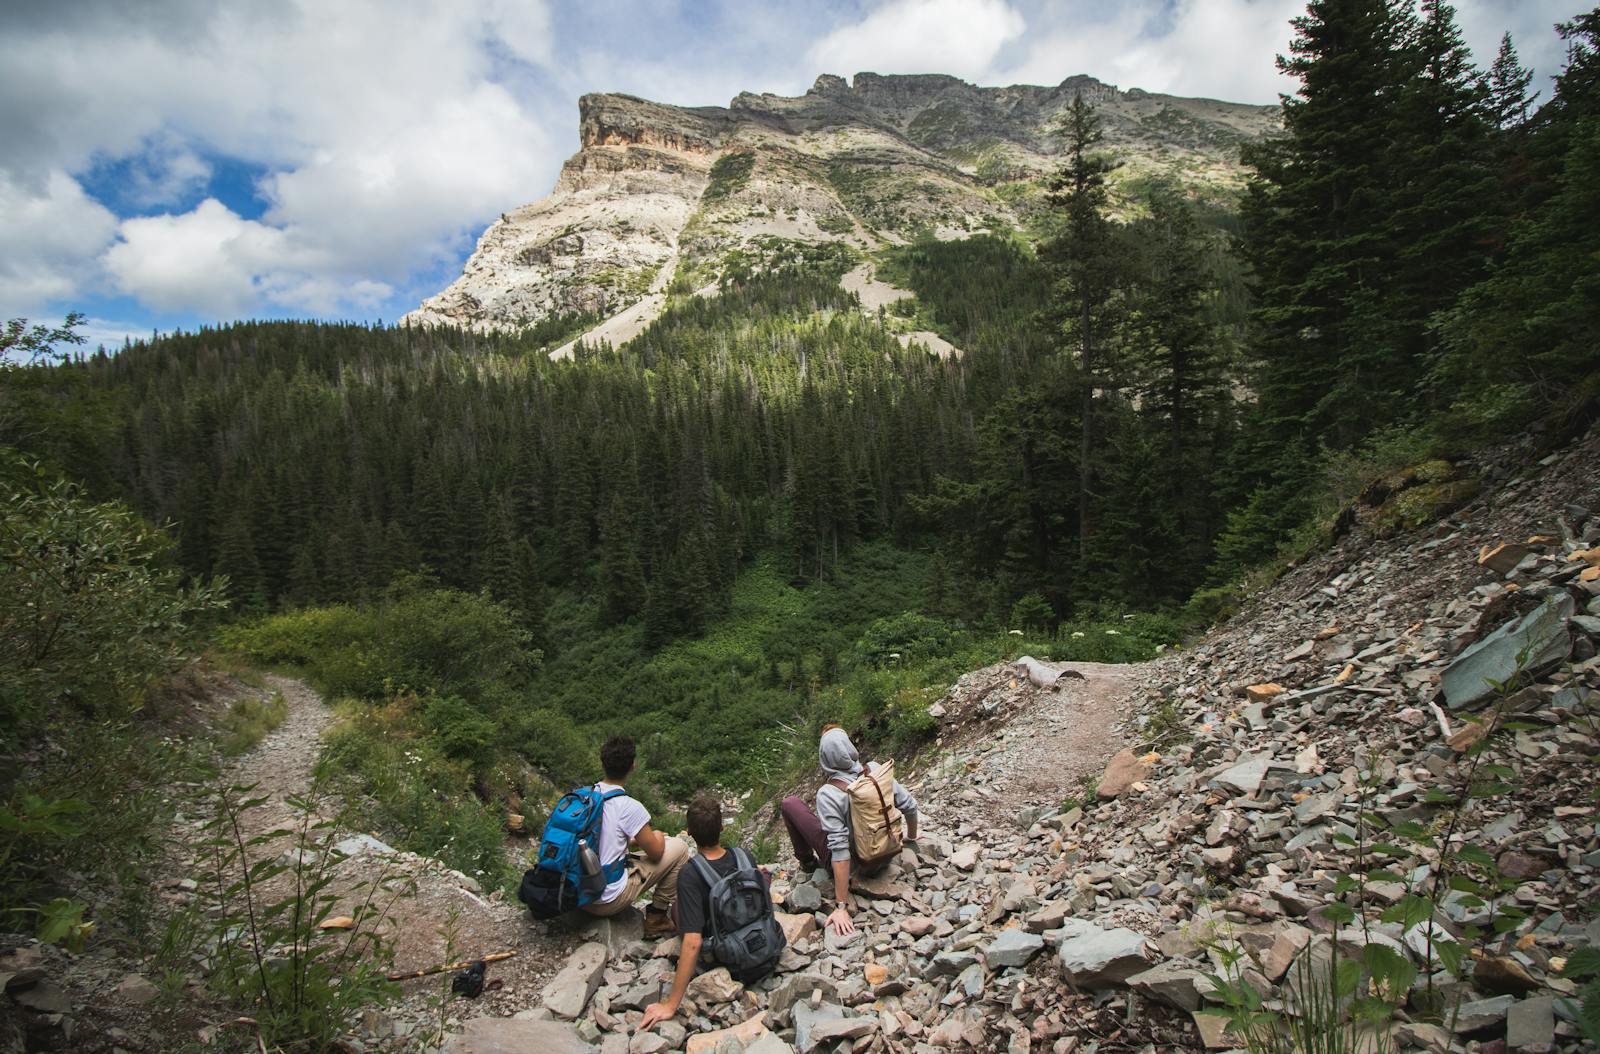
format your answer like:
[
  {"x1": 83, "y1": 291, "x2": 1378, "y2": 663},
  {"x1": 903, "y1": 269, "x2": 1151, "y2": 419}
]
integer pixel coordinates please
[{"x1": 405, "y1": 74, "x2": 1277, "y2": 328}]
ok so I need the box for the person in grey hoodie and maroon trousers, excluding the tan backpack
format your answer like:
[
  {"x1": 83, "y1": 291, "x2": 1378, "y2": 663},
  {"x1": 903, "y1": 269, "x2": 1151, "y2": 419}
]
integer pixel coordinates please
[{"x1": 782, "y1": 725, "x2": 917, "y2": 934}]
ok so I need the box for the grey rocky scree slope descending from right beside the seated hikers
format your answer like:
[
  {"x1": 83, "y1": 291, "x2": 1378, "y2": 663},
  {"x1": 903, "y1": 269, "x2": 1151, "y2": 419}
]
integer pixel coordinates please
[{"x1": 450, "y1": 435, "x2": 1600, "y2": 1054}]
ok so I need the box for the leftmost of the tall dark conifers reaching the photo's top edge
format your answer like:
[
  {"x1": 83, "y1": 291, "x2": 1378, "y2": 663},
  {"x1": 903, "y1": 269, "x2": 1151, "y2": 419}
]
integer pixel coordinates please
[{"x1": 1243, "y1": 0, "x2": 1414, "y2": 448}]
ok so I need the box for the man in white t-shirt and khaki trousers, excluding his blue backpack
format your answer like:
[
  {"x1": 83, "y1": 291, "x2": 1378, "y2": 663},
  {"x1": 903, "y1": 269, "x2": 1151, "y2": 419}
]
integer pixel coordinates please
[{"x1": 582, "y1": 736, "x2": 690, "y2": 937}]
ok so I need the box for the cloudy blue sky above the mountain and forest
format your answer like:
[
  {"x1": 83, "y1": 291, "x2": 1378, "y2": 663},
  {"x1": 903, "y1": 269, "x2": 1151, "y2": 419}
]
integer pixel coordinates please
[{"x1": 0, "y1": 0, "x2": 1581, "y2": 355}]
